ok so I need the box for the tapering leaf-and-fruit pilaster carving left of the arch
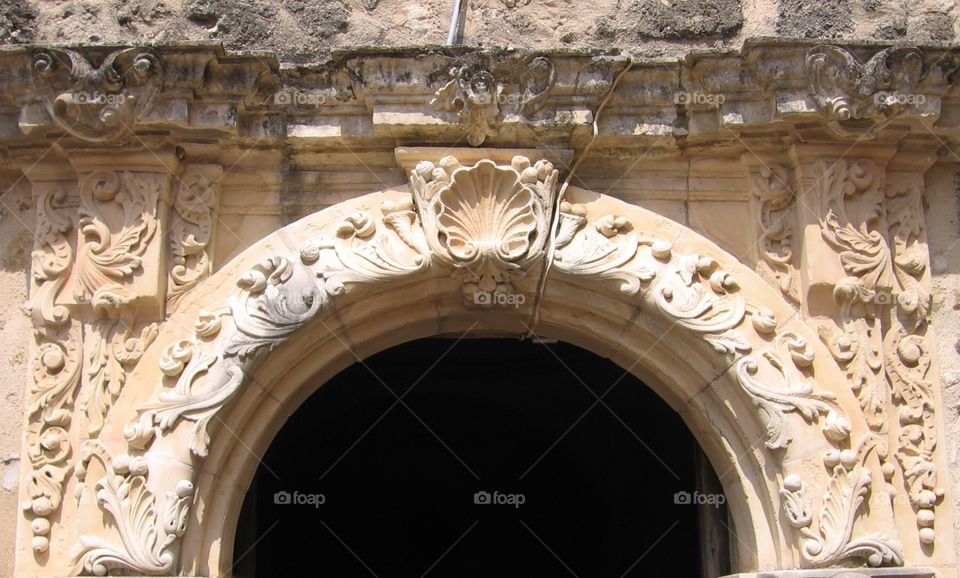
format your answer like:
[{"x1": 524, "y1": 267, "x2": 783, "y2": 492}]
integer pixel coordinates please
[{"x1": 24, "y1": 155, "x2": 176, "y2": 556}]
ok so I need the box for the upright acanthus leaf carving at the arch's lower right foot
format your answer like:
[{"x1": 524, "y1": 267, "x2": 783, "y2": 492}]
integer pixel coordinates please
[{"x1": 780, "y1": 434, "x2": 903, "y2": 568}]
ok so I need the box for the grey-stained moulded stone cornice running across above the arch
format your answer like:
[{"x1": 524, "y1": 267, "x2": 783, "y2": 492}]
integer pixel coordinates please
[{"x1": 0, "y1": 40, "x2": 960, "y2": 155}]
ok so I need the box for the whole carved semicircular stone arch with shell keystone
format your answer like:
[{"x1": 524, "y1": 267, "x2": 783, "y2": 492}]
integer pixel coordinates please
[{"x1": 74, "y1": 157, "x2": 944, "y2": 576}]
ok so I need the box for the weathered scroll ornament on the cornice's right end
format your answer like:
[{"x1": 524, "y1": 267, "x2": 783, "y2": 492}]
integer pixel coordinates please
[{"x1": 805, "y1": 45, "x2": 923, "y2": 137}]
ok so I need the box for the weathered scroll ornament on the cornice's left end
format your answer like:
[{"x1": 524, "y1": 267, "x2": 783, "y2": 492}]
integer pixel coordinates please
[{"x1": 33, "y1": 48, "x2": 163, "y2": 143}]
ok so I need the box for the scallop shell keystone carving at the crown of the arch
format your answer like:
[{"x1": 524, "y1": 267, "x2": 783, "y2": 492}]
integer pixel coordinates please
[{"x1": 410, "y1": 156, "x2": 558, "y2": 304}]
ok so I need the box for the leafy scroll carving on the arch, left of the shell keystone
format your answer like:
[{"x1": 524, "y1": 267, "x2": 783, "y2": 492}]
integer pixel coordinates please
[{"x1": 124, "y1": 201, "x2": 430, "y2": 457}]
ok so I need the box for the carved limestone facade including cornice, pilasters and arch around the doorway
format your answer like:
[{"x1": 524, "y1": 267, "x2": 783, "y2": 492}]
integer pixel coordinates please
[{"x1": 0, "y1": 41, "x2": 960, "y2": 578}]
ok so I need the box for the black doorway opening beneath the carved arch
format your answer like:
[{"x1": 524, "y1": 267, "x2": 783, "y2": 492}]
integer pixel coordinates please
[{"x1": 233, "y1": 339, "x2": 730, "y2": 578}]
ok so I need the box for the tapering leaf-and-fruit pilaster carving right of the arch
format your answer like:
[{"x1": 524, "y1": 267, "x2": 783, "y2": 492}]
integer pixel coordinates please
[{"x1": 815, "y1": 155, "x2": 944, "y2": 544}]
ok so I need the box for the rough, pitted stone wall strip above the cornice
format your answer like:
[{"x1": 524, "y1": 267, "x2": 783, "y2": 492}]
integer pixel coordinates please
[{"x1": 0, "y1": 0, "x2": 958, "y2": 63}]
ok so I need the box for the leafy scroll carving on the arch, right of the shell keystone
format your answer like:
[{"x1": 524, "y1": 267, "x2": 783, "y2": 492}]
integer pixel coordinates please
[{"x1": 554, "y1": 202, "x2": 851, "y2": 449}]
